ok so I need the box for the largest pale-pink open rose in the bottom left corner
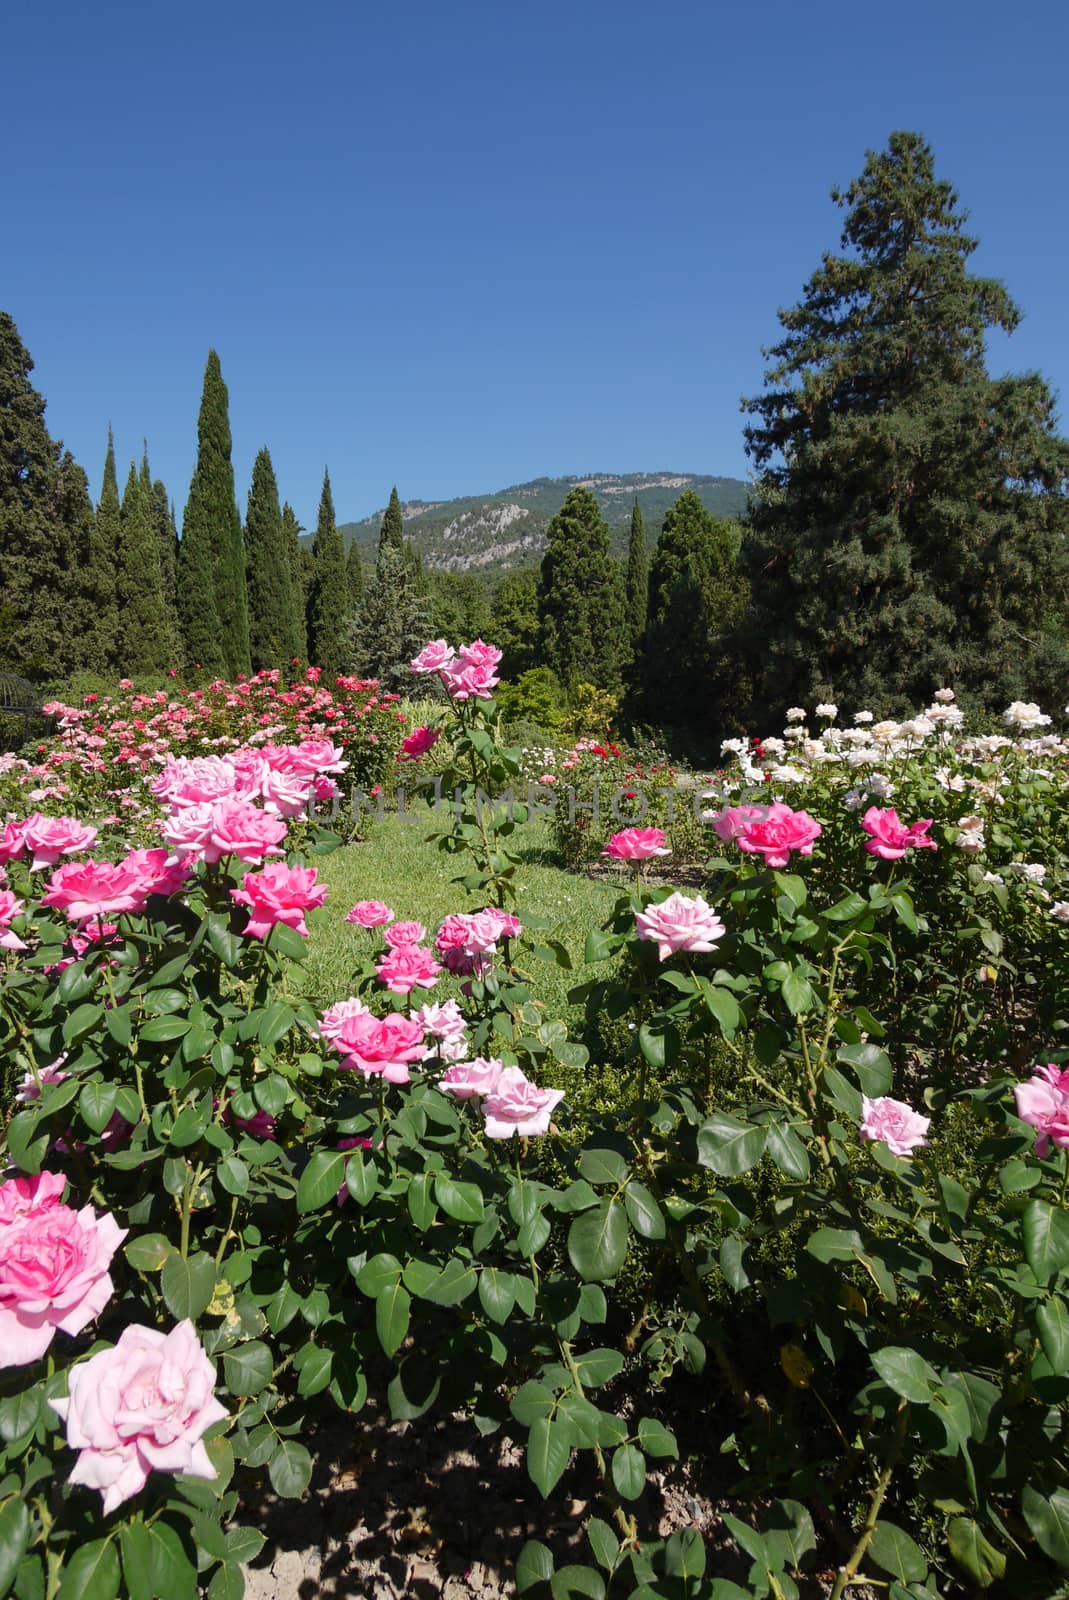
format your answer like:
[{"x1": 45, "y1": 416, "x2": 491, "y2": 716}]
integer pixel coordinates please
[{"x1": 48, "y1": 1322, "x2": 227, "y2": 1515}]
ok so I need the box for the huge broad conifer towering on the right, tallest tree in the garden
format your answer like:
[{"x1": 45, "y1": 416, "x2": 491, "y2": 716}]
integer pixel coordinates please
[{"x1": 744, "y1": 133, "x2": 1069, "y2": 717}]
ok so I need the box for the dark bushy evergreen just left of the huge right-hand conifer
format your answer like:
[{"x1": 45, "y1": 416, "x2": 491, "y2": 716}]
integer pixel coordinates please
[{"x1": 640, "y1": 490, "x2": 749, "y2": 739}]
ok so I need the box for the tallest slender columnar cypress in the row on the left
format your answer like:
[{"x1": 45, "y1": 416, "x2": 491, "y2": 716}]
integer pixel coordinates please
[{"x1": 178, "y1": 350, "x2": 250, "y2": 678}]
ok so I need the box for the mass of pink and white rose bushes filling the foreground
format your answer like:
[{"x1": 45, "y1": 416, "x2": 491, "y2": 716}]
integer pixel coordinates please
[{"x1": 0, "y1": 656, "x2": 1069, "y2": 1600}]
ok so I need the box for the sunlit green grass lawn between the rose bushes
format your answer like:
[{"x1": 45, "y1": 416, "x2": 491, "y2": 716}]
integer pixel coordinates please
[{"x1": 302, "y1": 816, "x2": 626, "y2": 1018}]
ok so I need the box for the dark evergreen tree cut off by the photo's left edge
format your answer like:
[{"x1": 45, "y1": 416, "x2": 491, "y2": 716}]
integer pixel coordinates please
[{"x1": 0, "y1": 312, "x2": 78, "y2": 677}]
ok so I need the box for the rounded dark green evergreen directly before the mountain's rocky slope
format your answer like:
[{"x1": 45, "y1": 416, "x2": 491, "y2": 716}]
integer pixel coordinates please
[{"x1": 538, "y1": 488, "x2": 627, "y2": 693}]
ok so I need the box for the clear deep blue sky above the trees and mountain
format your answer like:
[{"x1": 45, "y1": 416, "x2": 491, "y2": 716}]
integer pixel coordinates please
[{"x1": 8, "y1": 0, "x2": 1069, "y2": 523}]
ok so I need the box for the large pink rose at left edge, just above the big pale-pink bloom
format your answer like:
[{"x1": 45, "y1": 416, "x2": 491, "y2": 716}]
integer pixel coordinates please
[{"x1": 0, "y1": 1196, "x2": 126, "y2": 1366}]
